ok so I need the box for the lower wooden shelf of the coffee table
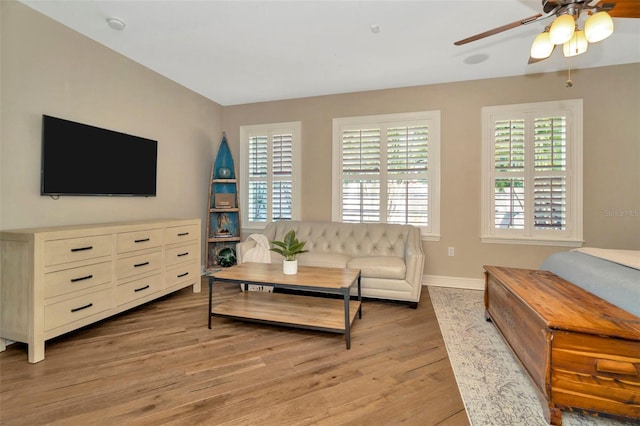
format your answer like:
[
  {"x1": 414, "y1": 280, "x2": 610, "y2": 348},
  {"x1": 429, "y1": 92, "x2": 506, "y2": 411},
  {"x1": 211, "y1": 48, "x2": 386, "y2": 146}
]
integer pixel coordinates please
[{"x1": 211, "y1": 291, "x2": 360, "y2": 334}]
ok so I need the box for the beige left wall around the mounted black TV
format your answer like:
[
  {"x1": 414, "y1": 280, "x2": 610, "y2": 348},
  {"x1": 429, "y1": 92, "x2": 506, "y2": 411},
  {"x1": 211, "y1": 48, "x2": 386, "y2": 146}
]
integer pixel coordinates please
[{"x1": 0, "y1": 1, "x2": 222, "y2": 260}]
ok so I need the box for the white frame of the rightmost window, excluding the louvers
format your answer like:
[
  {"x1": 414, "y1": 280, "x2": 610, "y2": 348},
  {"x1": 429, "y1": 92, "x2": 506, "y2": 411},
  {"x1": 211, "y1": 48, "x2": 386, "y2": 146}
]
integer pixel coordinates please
[{"x1": 481, "y1": 99, "x2": 584, "y2": 247}]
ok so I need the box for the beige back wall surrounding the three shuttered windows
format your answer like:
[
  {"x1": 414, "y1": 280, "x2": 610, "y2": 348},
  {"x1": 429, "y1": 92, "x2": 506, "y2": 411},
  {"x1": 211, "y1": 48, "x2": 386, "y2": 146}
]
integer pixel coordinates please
[{"x1": 223, "y1": 64, "x2": 640, "y2": 278}]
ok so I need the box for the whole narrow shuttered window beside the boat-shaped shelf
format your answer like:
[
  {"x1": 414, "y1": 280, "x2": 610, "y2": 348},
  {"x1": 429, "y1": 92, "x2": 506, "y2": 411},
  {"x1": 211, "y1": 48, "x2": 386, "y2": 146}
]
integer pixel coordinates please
[{"x1": 240, "y1": 122, "x2": 301, "y2": 229}]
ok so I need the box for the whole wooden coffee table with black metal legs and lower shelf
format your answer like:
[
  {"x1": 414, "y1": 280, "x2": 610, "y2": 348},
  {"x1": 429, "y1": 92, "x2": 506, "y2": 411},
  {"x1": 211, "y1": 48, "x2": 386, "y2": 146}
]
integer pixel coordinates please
[{"x1": 206, "y1": 262, "x2": 362, "y2": 349}]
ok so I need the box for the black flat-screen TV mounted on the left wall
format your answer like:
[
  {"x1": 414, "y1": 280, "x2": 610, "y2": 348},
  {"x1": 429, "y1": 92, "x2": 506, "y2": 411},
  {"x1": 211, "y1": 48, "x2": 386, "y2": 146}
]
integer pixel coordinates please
[{"x1": 40, "y1": 115, "x2": 158, "y2": 197}]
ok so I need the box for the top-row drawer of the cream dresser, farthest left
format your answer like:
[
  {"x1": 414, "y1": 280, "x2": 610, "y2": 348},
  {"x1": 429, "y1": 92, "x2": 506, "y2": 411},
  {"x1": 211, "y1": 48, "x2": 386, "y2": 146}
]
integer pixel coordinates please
[{"x1": 44, "y1": 235, "x2": 111, "y2": 266}]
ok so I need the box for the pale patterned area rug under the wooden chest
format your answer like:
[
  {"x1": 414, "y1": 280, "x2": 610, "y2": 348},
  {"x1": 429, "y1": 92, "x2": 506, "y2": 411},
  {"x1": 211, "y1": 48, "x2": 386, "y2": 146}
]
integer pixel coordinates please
[{"x1": 429, "y1": 287, "x2": 637, "y2": 426}]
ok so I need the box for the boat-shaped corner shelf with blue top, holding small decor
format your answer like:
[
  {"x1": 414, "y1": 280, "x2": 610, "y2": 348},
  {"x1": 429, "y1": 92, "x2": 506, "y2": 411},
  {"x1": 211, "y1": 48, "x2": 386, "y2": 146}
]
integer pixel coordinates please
[{"x1": 205, "y1": 132, "x2": 241, "y2": 269}]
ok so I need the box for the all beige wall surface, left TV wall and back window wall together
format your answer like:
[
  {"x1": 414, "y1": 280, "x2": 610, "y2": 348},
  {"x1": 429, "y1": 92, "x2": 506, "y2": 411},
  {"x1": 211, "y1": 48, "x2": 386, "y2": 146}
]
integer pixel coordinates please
[{"x1": 0, "y1": 1, "x2": 640, "y2": 278}]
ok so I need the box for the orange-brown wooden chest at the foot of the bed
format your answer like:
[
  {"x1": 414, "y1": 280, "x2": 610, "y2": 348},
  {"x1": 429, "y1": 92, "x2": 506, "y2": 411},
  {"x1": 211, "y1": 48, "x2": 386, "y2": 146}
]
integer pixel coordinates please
[{"x1": 484, "y1": 266, "x2": 640, "y2": 425}]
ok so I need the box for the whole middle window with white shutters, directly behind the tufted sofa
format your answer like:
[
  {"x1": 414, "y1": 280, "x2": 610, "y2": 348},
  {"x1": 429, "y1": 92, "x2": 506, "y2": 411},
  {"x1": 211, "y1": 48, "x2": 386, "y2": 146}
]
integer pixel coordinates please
[{"x1": 332, "y1": 111, "x2": 440, "y2": 240}]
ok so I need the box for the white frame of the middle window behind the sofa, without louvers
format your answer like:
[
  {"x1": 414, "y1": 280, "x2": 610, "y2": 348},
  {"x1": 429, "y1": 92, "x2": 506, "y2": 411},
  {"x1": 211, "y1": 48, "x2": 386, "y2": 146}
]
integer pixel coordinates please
[{"x1": 331, "y1": 110, "x2": 441, "y2": 241}]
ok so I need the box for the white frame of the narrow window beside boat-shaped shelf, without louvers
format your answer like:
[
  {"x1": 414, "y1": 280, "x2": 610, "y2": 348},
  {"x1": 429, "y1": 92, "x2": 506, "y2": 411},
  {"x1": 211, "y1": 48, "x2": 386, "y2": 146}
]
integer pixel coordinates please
[{"x1": 238, "y1": 121, "x2": 302, "y2": 230}]
